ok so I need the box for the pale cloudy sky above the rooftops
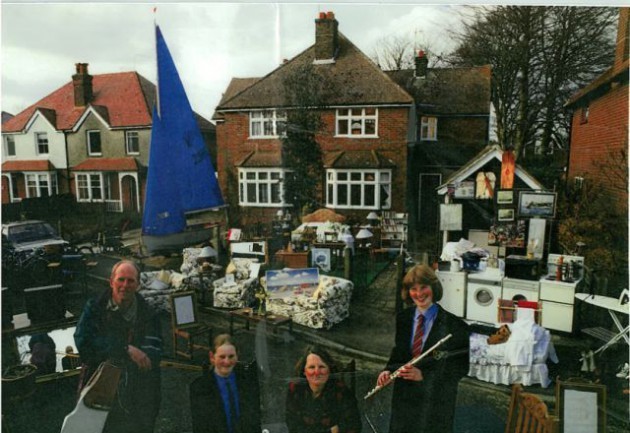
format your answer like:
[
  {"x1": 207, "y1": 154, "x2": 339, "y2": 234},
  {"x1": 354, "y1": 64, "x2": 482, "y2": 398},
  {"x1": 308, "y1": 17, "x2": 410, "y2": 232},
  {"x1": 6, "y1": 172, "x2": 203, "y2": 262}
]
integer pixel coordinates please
[{"x1": 0, "y1": 2, "x2": 470, "y2": 119}]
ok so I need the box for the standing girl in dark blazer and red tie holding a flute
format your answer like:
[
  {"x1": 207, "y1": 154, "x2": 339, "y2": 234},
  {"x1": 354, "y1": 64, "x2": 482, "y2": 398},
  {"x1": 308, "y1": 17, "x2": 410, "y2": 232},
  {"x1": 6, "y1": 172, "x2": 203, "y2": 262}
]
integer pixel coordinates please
[{"x1": 377, "y1": 265, "x2": 469, "y2": 433}]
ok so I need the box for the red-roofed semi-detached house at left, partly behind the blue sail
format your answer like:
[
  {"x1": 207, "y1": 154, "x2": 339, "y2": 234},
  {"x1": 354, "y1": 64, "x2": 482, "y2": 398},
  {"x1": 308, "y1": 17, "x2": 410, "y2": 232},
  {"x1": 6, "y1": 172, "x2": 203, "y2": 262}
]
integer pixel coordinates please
[{"x1": 2, "y1": 63, "x2": 215, "y2": 212}]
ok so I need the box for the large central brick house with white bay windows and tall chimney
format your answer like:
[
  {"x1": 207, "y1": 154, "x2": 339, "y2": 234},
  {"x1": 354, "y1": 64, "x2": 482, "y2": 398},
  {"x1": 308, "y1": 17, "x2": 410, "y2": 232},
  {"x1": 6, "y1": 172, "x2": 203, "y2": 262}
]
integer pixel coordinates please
[{"x1": 214, "y1": 12, "x2": 414, "y2": 238}]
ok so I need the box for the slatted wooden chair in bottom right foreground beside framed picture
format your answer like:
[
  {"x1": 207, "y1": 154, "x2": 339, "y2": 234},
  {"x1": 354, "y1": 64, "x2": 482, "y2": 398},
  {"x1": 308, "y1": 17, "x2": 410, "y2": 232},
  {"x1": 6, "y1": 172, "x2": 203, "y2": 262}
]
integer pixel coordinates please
[{"x1": 505, "y1": 383, "x2": 559, "y2": 433}]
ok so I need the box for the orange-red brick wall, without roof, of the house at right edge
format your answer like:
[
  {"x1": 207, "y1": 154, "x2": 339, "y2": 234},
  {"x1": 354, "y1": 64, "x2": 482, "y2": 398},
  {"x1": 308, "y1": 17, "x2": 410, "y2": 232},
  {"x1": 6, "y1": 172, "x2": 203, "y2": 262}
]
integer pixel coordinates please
[{"x1": 569, "y1": 82, "x2": 629, "y2": 207}]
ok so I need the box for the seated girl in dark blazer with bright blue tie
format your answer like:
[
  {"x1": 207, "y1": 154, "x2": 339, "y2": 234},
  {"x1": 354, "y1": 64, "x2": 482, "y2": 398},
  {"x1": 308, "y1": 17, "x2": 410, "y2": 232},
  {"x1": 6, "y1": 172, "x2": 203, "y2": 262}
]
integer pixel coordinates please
[{"x1": 190, "y1": 334, "x2": 261, "y2": 433}]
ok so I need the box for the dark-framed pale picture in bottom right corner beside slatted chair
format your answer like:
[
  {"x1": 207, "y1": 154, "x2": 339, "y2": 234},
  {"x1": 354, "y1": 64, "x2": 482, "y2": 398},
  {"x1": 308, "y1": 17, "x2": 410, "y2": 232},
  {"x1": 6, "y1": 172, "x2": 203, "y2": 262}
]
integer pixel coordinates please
[{"x1": 556, "y1": 380, "x2": 606, "y2": 433}]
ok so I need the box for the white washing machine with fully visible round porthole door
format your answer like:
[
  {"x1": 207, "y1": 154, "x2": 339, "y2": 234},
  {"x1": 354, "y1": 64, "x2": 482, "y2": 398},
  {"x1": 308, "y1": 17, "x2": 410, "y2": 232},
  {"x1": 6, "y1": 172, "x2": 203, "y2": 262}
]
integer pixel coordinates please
[{"x1": 466, "y1": 272, "x2": 502, "y2": 324}]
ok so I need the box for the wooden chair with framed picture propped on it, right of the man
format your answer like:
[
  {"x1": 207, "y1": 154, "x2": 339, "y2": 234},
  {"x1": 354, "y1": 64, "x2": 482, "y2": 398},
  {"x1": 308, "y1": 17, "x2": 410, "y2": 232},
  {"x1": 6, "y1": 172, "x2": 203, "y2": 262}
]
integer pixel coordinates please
[{"x1": 171, "y1": 292, "x2": 212, "y2": 361}]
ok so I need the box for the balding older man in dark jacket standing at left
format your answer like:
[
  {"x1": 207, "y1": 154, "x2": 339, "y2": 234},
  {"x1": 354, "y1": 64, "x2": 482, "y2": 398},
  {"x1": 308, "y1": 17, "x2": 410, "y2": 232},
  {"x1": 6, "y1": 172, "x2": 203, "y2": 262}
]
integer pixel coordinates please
[{"x1": 74, "y1": 260, "x2": 162, "y2": 433}]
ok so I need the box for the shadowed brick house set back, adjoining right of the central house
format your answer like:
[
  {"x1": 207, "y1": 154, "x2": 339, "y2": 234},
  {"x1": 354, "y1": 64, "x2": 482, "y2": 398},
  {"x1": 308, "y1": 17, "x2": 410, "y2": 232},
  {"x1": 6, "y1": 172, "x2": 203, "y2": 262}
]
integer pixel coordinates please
[{"x1": 387, "y1": 51, "x2": 492, "y2": 252}]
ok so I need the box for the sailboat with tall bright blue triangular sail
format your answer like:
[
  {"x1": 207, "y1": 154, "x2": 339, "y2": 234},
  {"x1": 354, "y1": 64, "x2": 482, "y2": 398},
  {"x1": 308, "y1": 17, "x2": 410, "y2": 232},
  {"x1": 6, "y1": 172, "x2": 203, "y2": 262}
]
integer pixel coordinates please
[{"x1": 142, "y1": 26, "x2": 224, "y2": 253}]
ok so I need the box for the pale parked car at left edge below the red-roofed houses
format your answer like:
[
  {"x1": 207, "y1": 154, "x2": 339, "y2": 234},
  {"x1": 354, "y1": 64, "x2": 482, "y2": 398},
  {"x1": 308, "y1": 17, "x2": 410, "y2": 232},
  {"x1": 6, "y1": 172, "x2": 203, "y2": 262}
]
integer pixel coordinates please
[{"x1": 2, "y1": 220, "x2": 68, "y2": 253}]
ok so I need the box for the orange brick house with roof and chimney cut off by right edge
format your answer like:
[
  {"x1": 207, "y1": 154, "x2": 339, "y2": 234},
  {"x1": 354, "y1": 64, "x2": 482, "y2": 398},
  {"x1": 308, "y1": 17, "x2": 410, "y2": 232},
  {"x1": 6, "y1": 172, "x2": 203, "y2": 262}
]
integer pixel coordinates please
[{"x1": 565, "y1": 8, "x2": 630, "y2": 208}]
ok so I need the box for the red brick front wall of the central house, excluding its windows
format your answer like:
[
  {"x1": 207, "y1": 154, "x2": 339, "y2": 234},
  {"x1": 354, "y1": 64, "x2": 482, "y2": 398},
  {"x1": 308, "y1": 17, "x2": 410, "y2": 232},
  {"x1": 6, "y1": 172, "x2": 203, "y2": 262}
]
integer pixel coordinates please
[{"x1": 217, "y1": 108, "x2": 408, "y2": 224}]
